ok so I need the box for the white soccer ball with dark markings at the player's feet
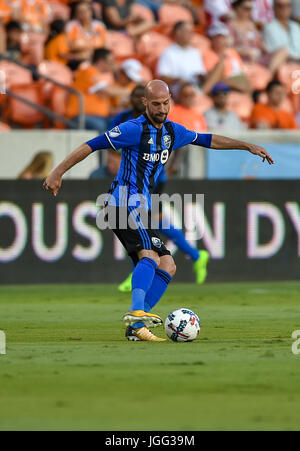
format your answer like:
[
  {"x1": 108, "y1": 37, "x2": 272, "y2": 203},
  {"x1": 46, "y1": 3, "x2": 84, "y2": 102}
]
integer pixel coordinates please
[{"x1": 165, "y1": 308, "x2": 201, "y2": 341}]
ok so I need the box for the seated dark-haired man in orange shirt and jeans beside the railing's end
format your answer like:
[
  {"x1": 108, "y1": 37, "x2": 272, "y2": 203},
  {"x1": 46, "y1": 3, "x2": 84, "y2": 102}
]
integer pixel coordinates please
[{"x1": 66, "y1": 48, "x2": 127, "y2": 133}]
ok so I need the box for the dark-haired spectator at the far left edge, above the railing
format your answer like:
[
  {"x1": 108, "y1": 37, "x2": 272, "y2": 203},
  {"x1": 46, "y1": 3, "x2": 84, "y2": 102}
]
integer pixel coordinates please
[{"x1": 0, "y1": 20, "x2": 23, "y2": 61}]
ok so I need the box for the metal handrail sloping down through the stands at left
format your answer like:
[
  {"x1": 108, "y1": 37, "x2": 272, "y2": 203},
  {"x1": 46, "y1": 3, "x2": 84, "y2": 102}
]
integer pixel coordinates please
[{"x1": 0, "y1": 55, "x2": 85, "y2": 130}]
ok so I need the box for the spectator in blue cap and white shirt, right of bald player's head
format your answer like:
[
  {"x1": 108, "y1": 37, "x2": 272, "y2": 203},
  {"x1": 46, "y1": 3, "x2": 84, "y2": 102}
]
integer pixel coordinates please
[{"x1": 204, "y1": 83, "x2": 247, "y2": 132}]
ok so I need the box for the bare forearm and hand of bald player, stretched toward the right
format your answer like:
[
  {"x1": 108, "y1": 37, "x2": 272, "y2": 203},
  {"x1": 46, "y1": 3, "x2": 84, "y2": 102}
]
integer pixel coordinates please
[{"x1": 209, "y1": 135, "x2": 274, "y2": 164}]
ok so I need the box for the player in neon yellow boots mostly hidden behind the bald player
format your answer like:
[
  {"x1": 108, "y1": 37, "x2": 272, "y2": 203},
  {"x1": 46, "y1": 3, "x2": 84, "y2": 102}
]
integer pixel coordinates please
[{"x1": 110, "y1": 85, "x2": 210, "y2": 292}]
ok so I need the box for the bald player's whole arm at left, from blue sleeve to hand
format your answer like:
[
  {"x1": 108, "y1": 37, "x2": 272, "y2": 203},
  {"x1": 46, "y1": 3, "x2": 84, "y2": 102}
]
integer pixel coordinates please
[{"x1": 43, "y1": 121, "x2": 140, "y2": 196}]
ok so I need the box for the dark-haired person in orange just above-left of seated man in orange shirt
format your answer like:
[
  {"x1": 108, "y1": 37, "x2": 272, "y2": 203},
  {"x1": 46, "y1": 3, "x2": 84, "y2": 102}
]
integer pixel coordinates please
[{"x1": 45, "y1": 19, "x2": 73, "y2": 65}]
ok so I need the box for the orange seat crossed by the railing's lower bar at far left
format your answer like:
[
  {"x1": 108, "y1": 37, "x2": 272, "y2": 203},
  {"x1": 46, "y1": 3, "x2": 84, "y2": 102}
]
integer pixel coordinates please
[{"x1": 3, "y1": 83, "x2": 45, "y2": 128}]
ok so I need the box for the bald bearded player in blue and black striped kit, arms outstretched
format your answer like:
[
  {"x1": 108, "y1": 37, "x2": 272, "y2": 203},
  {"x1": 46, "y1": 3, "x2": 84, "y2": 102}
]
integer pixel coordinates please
[{"x1": 44, "y1": 80, "x2": 274, "y2": 341}]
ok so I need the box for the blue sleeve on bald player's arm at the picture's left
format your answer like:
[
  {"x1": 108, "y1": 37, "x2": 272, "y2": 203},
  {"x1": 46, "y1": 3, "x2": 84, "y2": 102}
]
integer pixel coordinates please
[{"x1": 87, "y1": 121, "x2": 141, "y2": 152}]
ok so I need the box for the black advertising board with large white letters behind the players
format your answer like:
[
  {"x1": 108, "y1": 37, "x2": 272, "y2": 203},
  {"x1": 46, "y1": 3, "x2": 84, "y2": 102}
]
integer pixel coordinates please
[{"x1": 0, "y1": 180, "x2": 300, "y2": 284}]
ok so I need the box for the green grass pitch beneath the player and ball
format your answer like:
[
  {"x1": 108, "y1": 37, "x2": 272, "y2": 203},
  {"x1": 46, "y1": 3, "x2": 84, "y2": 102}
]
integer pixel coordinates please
[{"x1": 0, "y1": 282, "x2": 300, "y2": 431}]
